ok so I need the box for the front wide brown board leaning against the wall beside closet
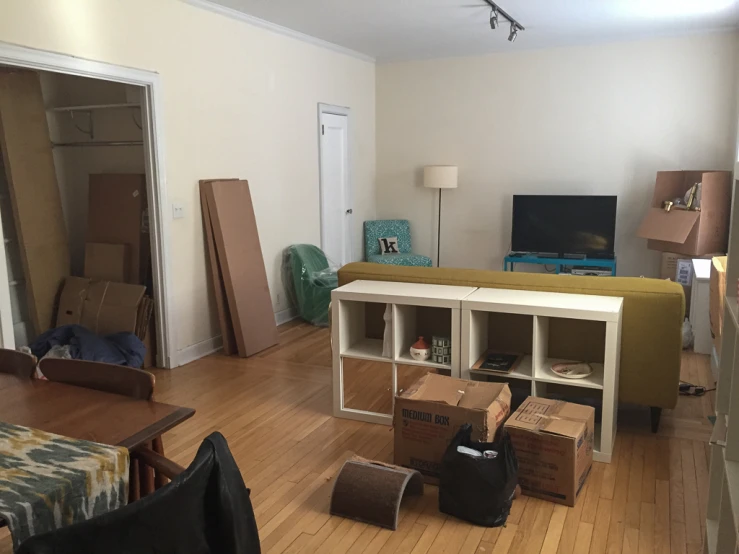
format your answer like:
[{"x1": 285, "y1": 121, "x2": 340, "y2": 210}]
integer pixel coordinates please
[{"x1": 206, "y1": 181, "x2": 279, "y2": 357}]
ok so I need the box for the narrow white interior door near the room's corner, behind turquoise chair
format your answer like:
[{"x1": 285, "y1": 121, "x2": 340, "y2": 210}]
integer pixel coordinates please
[{"x1": 320, "y1": 112, "x2": 352, "y2": 266}]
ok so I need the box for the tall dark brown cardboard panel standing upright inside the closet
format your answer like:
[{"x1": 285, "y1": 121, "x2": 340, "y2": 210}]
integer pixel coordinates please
[{"x1": 86, "y1": 173, "x2": 151, "y2": 285}]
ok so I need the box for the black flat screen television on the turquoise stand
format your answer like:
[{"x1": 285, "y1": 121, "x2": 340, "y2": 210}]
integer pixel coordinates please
[{"x1": 511, "y1": 194, "x2": 616, "y2": 257}]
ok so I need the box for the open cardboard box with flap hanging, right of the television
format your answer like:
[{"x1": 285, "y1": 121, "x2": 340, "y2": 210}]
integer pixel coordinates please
[{"x1": 637, "y1": 171, "x2": 731, "y2": 256}]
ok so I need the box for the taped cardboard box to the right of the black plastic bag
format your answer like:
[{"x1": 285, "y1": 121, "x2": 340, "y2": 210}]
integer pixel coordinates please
[{"x1": 505, "y1": 396, "x2": 595, "y2": 506}]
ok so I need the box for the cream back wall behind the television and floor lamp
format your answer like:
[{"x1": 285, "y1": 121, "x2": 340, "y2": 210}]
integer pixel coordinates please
[{"x1": 377, "y1": 34, "x2": 737, "y2": 276}]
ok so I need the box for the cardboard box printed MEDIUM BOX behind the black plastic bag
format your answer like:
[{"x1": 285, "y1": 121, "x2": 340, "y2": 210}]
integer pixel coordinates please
[{"x1": 393, "y1": 373, "x2": 511, "y2": 483}]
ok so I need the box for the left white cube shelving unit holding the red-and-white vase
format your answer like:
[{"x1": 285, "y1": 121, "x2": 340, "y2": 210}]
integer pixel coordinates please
[{"x1": 331, "y1": 281, "x2": 476, "y2": 425}]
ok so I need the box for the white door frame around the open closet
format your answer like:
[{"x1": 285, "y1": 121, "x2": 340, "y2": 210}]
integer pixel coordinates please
[{"x1": 0, "y1": 41, "x2": 178, "y2": 368}]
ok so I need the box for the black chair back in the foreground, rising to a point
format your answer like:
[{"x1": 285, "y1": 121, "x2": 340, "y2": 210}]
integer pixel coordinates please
[{"x1": 17, "y1": 433, "x2": 260, "y2": 554}]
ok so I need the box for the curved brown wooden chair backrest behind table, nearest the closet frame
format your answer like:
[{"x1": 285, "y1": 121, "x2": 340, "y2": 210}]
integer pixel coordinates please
[{"x1": 39, "y1": 358, "x2": 155, "y2": 400}]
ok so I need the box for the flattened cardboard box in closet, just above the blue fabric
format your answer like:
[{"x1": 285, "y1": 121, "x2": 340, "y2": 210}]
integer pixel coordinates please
[{"x1": 56, "y1": 277, "x2": 146, "y2": 335}]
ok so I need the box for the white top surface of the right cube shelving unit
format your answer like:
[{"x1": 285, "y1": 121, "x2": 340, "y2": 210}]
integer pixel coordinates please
[{"x1": 462, "y1": 288, "x2": 623, "y2": 319}]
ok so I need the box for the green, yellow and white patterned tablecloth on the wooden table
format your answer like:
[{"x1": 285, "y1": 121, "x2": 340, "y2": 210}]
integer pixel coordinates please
[{"x1": 0, "y1": 421, "x2": 129, "y2": 549}]
